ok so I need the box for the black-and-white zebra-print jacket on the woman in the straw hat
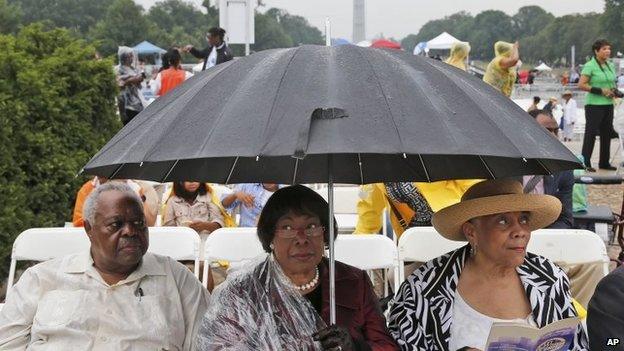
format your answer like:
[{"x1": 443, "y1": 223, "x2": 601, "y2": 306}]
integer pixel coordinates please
[{"x1": 388, "y1": 245, "x2": 589, "y2": 351}]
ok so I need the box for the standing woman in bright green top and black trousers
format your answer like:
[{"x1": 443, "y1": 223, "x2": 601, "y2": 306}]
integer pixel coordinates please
[{"x1": 578, "y1": 39, "x2": 616, "y2": 172}]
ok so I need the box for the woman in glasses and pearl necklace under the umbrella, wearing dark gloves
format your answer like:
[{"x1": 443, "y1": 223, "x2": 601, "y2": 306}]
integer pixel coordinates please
[{"x1": 197, "y1": 185, "x2": 398, "y2": 351}]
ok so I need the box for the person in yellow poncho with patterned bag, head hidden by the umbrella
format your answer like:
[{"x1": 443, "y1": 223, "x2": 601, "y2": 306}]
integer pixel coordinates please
[{"x1": 354, "y1": 179, "x2": 480, "y2": 237}]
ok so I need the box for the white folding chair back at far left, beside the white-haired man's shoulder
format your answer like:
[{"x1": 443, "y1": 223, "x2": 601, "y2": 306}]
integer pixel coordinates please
[{"x1": 7, "y1": 227, "x2": 90, "y2": 296}]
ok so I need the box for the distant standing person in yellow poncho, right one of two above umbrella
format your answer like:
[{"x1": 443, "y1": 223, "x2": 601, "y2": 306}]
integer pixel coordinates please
[{"x1": 483, "y1": 41, "x2": 520, "y2": 96}]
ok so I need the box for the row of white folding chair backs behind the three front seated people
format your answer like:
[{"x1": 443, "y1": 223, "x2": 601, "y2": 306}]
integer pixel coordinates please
[{"x1": 7, "y1": 227, "x2": 609, "y2": 294}]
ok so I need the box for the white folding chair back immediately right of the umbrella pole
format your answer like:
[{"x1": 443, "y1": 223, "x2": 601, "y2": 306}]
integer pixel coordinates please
[{"x1": 334, "y1": 234, "x2": 399, "y2": 296}]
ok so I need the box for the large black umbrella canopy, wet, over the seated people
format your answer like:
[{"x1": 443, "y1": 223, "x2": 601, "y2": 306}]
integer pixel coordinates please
[{"x1": 84, "y1": 45, "x2": 581, "y2": 184}]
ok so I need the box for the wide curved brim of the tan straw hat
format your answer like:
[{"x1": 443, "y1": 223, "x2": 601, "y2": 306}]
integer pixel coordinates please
[{"x1": 431, "y1": 194, "x2": 561, "y2": 241}]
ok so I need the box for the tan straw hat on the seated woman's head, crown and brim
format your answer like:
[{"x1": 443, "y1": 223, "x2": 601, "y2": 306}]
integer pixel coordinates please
[{"x1": 432, "y1": 179, "x2": 561, "y2": 241}]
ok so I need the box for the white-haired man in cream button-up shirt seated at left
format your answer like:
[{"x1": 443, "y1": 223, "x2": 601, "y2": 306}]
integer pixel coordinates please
[{"x1": 0, "y1": 182, "x2": 208, "y2": 350}]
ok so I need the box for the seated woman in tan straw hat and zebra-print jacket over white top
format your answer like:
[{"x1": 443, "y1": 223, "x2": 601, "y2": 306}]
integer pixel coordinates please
[{"x1": 389, "y1": 180, "x2": 588, "y2": 351}]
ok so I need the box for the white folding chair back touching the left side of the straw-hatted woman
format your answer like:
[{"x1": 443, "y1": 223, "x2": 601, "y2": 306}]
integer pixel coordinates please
[{"x1": 395, "y1": 227, "x2": 466, "y2": 285}]
